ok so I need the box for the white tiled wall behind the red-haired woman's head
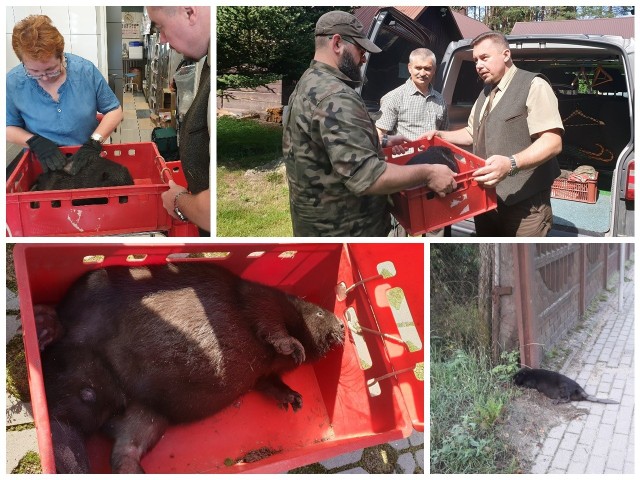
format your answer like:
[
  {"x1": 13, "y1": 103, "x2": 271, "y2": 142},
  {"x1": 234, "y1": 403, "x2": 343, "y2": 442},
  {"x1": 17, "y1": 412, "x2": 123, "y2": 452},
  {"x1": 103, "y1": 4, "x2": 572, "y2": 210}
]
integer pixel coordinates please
[{"x1": 6, "y1": 6, "x2": 107, "y2": 78}]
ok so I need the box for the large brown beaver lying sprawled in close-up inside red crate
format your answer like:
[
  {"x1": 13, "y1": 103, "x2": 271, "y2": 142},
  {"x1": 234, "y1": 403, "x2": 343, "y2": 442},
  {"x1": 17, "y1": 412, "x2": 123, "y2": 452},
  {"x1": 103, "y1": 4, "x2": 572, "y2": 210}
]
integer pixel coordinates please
[{"x1": 37, "y1": 262, "x2": 345, "y2": 473}]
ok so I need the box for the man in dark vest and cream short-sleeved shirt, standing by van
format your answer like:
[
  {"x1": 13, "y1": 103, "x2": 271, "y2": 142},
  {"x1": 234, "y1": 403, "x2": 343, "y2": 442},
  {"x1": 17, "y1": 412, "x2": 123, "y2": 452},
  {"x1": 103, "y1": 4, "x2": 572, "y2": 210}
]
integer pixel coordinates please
[{"x1": 425, "y1": 32, "x2": 564, "y2": 237}]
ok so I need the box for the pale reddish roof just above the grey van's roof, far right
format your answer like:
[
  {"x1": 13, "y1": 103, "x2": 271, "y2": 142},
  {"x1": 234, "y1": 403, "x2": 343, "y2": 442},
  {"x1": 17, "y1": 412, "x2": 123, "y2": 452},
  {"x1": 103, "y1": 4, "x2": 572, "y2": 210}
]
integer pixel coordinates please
[{"x1": 511, "y1": 16, "x2": 634, "y2": 38}]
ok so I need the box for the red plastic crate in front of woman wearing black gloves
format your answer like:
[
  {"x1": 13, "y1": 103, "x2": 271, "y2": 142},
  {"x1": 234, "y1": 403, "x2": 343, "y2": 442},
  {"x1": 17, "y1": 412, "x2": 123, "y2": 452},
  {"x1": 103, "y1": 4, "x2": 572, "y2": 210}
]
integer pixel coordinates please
[{"x1": 6, "y1": 142, "x2": 197, "y2": 236}]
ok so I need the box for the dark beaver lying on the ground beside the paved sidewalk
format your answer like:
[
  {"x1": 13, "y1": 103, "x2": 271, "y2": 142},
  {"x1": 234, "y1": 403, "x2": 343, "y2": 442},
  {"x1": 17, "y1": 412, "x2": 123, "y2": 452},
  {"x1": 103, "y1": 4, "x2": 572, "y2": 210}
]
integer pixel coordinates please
[{"x1": 513, "y1": 368, "x2": 618, "y2": 403}]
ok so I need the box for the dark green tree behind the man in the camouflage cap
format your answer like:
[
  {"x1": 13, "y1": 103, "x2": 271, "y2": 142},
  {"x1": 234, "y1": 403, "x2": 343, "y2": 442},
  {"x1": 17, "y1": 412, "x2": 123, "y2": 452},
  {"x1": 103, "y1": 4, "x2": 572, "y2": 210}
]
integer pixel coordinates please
[{"x1": 216, "y1": 6, "x2": 352, "y2": 102}]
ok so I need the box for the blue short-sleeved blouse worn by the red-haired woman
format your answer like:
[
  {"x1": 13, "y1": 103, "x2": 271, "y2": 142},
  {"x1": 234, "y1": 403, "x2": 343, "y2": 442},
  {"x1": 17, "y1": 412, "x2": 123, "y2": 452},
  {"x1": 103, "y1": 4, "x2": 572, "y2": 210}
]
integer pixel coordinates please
[{"x1": 7, "y1": 53, "x2": 120, "y2": 145}]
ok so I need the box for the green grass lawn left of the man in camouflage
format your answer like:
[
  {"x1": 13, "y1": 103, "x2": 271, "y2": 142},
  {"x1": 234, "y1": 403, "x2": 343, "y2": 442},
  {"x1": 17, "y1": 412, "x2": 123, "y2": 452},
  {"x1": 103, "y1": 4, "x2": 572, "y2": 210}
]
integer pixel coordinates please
[{"x1": 216, "y1": 117, "x2": 293, "y2": 237}]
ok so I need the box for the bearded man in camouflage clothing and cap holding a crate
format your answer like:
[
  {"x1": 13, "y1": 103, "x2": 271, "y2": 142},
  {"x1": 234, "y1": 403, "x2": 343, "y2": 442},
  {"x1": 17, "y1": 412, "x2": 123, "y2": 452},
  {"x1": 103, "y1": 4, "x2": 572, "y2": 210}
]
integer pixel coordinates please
[{"x1": 283, "y1": 11, "x2": 456, "y2": 237}]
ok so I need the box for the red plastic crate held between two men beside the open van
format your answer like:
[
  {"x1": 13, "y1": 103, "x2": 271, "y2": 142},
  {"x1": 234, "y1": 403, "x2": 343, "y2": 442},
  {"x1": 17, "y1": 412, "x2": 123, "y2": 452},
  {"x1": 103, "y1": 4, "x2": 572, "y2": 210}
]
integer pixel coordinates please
[{"x1": 384, "y1": 137, "x2": 498, "y2": 235}]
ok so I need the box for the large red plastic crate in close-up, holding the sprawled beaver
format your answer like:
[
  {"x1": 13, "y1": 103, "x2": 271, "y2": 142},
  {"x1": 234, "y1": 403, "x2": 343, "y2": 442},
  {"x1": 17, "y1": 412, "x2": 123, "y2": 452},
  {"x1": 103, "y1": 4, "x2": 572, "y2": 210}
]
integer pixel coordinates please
[{"x1": 14, "y1": 244, "x2": 424, "y2": 473}]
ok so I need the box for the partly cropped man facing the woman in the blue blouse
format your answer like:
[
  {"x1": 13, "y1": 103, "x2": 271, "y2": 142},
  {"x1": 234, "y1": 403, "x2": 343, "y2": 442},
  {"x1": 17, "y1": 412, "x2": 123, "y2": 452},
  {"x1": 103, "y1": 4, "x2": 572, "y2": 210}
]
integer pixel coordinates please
[{"x1": 147, "y1": 6, "x2": 211, "y2": 236}]
